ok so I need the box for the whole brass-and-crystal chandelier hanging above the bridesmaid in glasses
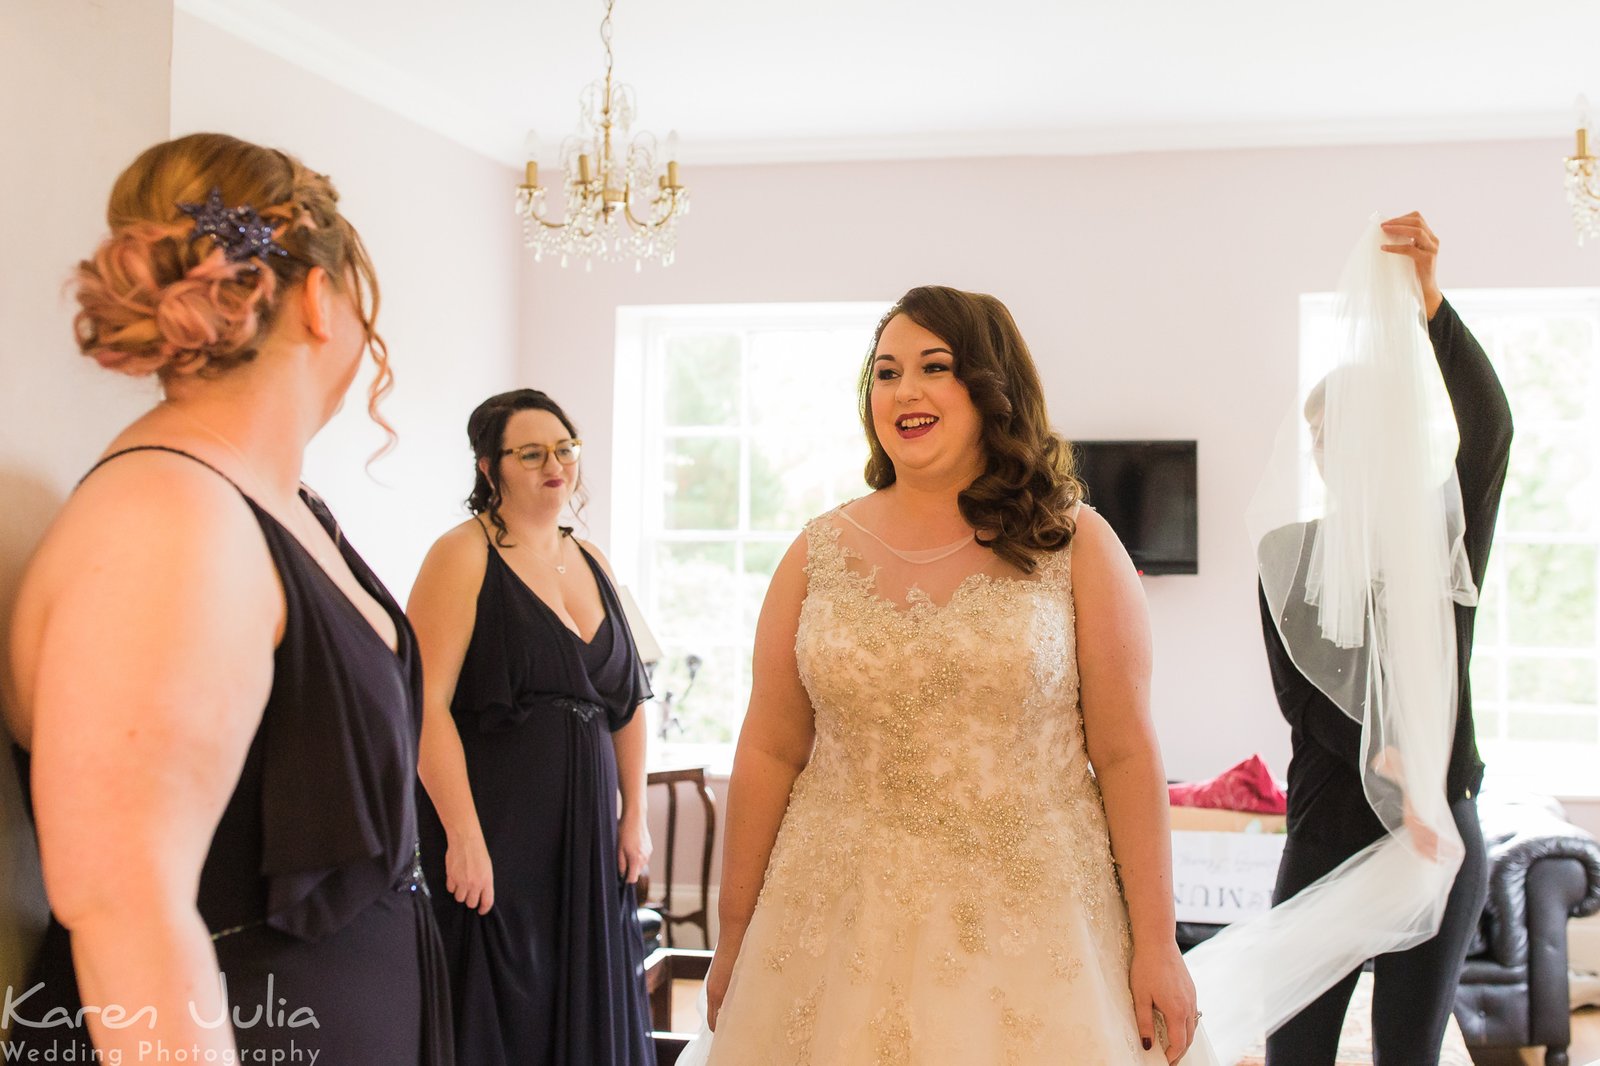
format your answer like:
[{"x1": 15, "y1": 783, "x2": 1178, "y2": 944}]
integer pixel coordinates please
[{"x1": 517, "y1": 0, "x2": 690, "y2": 271}]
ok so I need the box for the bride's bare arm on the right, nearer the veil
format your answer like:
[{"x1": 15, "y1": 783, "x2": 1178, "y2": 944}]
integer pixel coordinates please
[{"x1": 1072, "y1": 507, "x2": 1195, "y2": 1063}]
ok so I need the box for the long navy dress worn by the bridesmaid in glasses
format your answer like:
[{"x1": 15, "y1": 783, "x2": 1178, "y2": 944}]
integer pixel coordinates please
[{"x1": 418, "y1": 521, "x2": 656, "y2": 1066}]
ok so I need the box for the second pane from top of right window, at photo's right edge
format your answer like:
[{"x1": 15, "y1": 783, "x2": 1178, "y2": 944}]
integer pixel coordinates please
[{"x1": 1501, "y1": 423, "x2": 1597, "y2": 533}]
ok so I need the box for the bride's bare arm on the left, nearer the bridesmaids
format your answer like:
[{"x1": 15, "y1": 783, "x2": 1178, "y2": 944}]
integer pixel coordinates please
[{"x1": 706, "y1": 535, "x2": 814, "y2": 1028}]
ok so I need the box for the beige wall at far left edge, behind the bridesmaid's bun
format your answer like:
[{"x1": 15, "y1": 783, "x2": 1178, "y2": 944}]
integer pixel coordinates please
[{"x1": 0, "y1": 0, "x2": 173, "y2": 1039}]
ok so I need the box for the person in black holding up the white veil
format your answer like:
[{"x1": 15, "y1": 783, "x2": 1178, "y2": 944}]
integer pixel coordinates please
[{"x1": 1261, "y1": 213, "x2": 1512, "y2": 1066}]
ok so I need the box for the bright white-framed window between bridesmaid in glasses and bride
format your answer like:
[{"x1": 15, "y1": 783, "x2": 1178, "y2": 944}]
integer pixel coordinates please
[{"x1": 614, "y1": 307, "x2": 921, "y2": 743}]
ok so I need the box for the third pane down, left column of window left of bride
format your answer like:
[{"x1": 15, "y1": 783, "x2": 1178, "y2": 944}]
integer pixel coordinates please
[{"x1": 651, "y1": 543, "x2": 744, "y2": 640}]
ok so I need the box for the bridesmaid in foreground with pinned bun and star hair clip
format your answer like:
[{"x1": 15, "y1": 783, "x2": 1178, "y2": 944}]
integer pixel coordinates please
[{"x1": 6, "y1": 134, "x2": 453, "y2": 1066}]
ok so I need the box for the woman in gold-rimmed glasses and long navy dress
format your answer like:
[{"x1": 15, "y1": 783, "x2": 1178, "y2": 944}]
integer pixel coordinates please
[{"x1": 408, "y1": 389, "x2": 654, "y2": 1066}]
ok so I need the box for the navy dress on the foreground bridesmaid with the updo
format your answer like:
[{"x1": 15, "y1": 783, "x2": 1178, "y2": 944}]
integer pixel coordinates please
[{"x1": 11, "y1": 447, "x2": 454, "y2": 1066}]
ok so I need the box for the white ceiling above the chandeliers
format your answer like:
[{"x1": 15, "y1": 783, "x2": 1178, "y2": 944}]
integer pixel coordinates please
[{"x1": 178, "y1": 0, "x2": 1600, "y2": 165}]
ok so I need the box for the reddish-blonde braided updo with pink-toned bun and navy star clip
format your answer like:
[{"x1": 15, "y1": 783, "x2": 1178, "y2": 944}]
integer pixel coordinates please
[{"x1": 74, "y1": 133, "x2": 394, "y2": 423}]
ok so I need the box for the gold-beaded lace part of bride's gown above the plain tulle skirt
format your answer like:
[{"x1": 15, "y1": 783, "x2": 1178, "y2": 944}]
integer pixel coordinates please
[{"x1": 752, "y1": 514, "x2": 1114, "y2": 981}]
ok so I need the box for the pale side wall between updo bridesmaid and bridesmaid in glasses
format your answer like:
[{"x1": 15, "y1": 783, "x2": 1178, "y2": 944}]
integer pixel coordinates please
[{"x1": 171, "y1": 11, "x2": 522, "y2": 602}]
